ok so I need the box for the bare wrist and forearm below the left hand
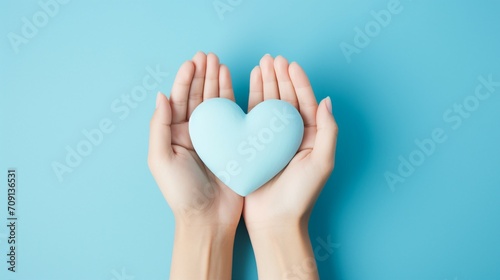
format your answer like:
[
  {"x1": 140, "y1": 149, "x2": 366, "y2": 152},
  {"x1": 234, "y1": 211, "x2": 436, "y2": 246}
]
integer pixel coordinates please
[{"x1": 170, "y1": 225, "x2": 235, "y2": 280}]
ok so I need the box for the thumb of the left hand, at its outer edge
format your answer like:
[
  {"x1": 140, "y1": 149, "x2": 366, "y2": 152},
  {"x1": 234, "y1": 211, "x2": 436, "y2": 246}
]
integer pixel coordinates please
[{"x1": 148, "y1": 93, "x2": 173, "y2": 166}]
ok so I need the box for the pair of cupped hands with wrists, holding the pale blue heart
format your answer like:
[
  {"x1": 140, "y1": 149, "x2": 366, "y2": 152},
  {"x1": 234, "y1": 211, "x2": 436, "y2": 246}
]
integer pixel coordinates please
[{"x1": 148, "y1": 52, "x2": 337, "y2": 279}]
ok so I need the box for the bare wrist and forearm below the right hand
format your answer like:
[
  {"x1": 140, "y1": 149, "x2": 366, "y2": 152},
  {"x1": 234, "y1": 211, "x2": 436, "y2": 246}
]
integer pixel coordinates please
[{"x1": 250, "y1": 224, "x2": 319, "y2": 280}]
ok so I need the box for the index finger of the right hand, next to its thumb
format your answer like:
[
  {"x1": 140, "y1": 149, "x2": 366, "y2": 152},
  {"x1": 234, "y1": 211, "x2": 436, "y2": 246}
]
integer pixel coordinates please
[{"x1": 288, "y1": 62, "x2": 318, "y2": 127}]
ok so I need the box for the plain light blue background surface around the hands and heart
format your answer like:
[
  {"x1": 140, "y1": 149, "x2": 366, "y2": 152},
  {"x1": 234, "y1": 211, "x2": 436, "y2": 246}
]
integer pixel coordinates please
[{"x1": 0, "y1": 0, "x2": 500, "y2": 280}]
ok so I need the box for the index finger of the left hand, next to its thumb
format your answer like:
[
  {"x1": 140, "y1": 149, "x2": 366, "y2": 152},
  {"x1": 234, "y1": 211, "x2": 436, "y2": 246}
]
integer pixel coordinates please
[{"x1": 170, "y1": 61, "x2": 194, "y2": 123}]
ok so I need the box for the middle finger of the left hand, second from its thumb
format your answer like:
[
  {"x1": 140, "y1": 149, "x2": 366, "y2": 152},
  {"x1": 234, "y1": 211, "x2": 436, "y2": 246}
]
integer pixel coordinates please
[{"x1": 187, "y1": 52, "x2": 207, "y2": 118}]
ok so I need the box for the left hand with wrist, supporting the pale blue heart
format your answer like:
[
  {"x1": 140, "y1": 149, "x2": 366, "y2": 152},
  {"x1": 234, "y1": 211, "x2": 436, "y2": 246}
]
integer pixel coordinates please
[{"x1": 148, "y1": 52, "x2": 243, "y2": 279}]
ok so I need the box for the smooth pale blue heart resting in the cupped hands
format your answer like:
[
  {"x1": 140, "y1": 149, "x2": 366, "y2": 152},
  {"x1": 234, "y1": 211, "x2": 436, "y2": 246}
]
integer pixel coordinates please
[{"x1": 189, "y1": 98, "x2": 304, "y2": 196}]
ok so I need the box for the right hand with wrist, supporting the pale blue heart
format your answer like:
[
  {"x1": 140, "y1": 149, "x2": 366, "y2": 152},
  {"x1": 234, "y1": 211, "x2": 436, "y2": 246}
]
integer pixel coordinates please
[{"x1": 243, "y1": 55, "x2": 337, "y2": 279}]
